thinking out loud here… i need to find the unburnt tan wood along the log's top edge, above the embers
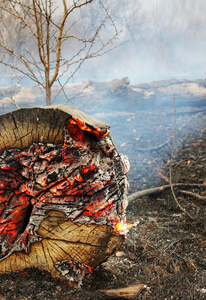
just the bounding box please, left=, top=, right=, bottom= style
left=0, top=105, right=109, bottom=152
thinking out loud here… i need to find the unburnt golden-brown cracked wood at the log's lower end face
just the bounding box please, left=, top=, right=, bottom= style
left=0, top=211, right=123, bottom=278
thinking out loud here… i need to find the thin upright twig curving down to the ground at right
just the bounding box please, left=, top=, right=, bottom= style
left=169, top=95, right=195, bottom=221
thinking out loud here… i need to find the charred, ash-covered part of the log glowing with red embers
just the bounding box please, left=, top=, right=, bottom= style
left=0, top=117, right=130, bottom=273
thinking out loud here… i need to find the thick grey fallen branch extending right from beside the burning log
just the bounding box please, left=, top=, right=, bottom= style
left=127, top=183, right=204, bottom=203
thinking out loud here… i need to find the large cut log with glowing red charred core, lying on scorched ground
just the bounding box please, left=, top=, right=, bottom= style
left=0, top=105, right=128, bottom=281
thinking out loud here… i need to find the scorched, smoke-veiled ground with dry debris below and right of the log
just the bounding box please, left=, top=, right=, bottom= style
left=0, top=90, right=206, bottom=300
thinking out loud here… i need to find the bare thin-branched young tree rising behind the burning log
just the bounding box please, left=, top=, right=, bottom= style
left=0, top=0, right=118, bottom=105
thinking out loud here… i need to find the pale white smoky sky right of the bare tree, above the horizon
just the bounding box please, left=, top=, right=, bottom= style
left=76, top=0, right=206, bottom=84
